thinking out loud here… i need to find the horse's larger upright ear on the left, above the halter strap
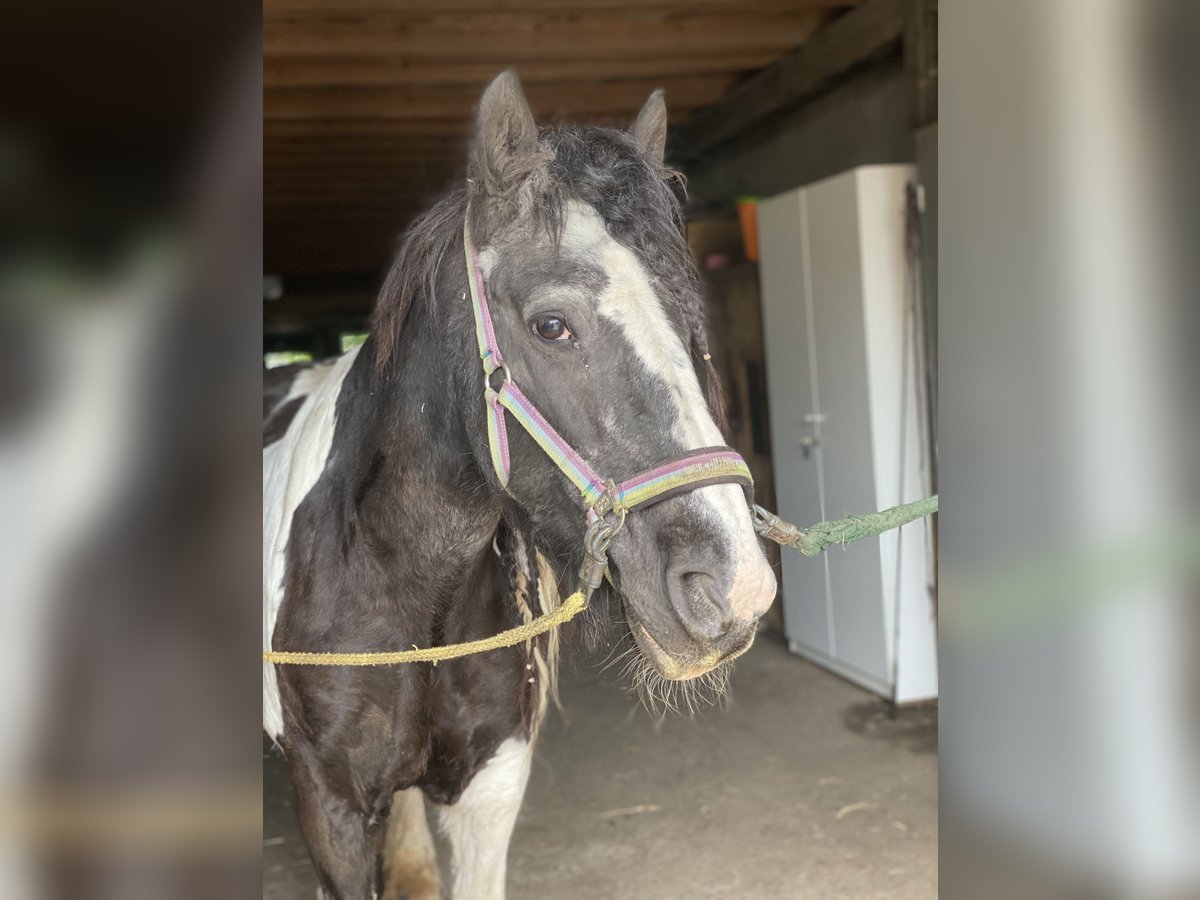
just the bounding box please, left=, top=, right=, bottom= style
left=467, top=68, right=541, bottom=197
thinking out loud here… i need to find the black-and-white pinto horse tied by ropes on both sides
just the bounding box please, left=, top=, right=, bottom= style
left=263, top=72, right=775, bottom=900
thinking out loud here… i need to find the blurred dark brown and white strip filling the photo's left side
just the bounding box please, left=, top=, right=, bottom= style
left=0, top=4, right=262, bottom=898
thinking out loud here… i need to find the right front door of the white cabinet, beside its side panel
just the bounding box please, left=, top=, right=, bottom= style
left=803, top=170, right=899, bottom=692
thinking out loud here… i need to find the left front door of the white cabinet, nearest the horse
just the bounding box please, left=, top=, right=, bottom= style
left=758, top=191, right=832, bottom=656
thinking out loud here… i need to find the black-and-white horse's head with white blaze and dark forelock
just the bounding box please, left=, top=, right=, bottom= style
left=384, top=73, right=775, bottom=696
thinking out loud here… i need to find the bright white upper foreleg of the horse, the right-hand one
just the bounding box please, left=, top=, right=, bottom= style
left=440, top=738, right=533, bottom=900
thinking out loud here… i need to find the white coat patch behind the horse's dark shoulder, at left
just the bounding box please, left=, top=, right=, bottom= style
left=263, top=347, right=359, bottom=740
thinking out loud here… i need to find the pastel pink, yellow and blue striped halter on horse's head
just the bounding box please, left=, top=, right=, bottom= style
left=462, top=216, right=754, bottom=539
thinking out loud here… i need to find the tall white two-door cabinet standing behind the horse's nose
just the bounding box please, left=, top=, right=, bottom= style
left=758, top=166, right=937, bottom=703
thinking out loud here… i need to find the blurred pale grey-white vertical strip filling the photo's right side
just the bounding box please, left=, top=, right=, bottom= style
left=938, top=0, right=1200, bottom=898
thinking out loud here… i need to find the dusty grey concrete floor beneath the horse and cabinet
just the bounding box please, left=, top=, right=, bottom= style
left=263, top=632, right=937, bottom=900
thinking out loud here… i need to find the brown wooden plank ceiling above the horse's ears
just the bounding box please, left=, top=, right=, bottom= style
left=263, top=0, right=856, bottom=275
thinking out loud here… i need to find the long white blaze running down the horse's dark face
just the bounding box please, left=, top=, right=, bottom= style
left=563, top=202, right=775, bottom=619
